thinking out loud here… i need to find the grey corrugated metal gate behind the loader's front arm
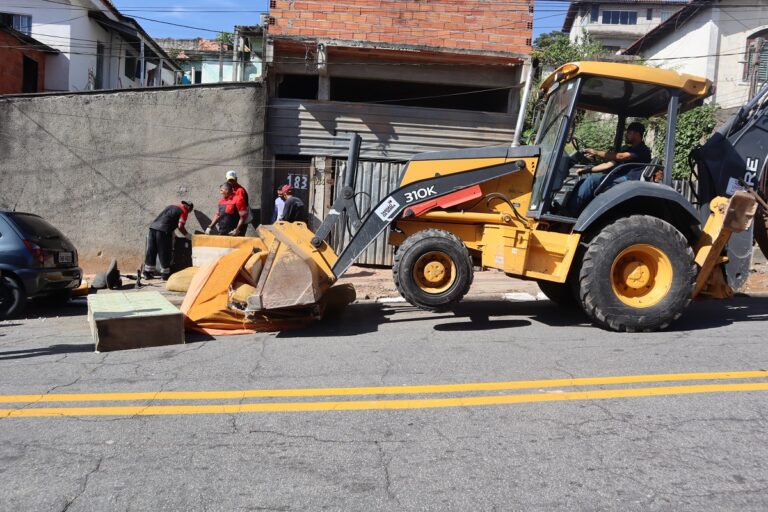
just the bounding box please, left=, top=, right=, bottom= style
left=331, top=160, right=406, bottom=266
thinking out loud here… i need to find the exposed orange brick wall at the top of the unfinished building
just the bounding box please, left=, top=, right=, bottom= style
left=268, top=0, right=533, bottom=54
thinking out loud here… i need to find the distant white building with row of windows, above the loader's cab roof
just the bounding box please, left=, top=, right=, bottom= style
left=563, top=0, right=689, bottom=52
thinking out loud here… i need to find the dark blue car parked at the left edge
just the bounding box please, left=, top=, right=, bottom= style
left=0, top=210, right=83, bottom=317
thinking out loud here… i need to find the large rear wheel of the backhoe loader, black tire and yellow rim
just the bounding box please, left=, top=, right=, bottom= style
left=578, top=215, right=696, bottom=332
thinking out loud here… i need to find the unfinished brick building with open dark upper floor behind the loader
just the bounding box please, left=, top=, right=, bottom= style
left=264, top=0, right=533, bottom=264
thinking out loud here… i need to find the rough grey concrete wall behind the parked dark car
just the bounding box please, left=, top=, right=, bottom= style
left=0, top=82, right=265, bottom=272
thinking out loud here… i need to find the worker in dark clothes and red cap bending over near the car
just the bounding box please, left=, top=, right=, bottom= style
left=143, top=201, right=195, bottom=280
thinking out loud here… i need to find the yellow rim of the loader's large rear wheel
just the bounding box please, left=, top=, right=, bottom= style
left=611, top=244, right=672, bottom=308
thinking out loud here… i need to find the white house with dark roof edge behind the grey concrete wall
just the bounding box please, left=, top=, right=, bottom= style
left=0, top=0, right=180, bottom=91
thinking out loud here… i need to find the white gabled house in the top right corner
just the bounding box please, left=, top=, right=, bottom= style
left=625, top=0, right=768, bottom=109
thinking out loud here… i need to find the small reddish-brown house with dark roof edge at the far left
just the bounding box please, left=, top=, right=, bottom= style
left=0, top=24, right=59, bottom=95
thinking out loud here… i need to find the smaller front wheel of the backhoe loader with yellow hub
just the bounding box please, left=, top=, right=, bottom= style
left=392, top=229, right=473, bottom=311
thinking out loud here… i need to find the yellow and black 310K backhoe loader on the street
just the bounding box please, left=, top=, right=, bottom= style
left=183, top=62, right=768, bottom=331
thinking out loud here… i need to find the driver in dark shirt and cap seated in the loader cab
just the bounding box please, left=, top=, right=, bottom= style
left=568, top=122, right=651, bottom=215
